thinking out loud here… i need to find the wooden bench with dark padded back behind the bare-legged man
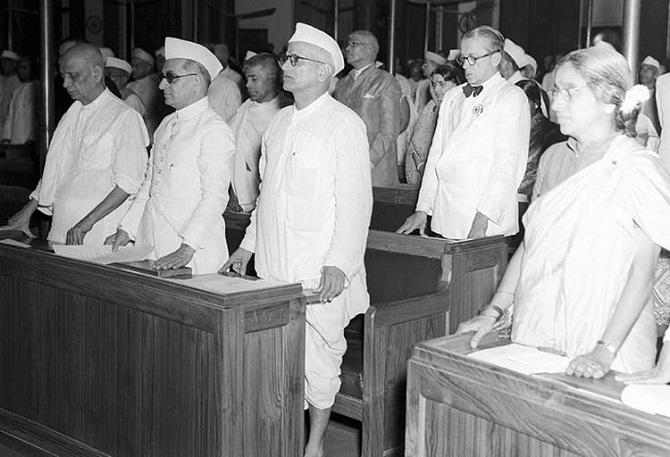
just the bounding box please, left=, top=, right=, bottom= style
left=226, top=217, right=507, bottom=457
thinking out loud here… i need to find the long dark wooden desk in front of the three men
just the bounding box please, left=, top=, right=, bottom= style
left=0, top=240, right=305, bottom=457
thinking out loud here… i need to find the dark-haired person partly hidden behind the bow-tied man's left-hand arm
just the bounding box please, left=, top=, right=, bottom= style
left=405, top=63, right=465, bottom=185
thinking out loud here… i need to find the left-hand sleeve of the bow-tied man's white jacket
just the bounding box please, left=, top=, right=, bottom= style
left=416, top=95, right=452, bottom=215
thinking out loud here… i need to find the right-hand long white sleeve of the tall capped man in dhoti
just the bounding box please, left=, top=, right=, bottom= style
left=324, top=122, right=372, bottom=279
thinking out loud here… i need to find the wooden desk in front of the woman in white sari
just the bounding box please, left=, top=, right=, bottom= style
left=405, top=334, right=670, bottom=457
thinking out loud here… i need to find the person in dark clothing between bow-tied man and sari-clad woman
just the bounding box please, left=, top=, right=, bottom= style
left=516, top=79, right=565, bottom=202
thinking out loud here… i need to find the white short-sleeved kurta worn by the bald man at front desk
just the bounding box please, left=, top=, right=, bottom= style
left=31, top=89, right=149, bottom=244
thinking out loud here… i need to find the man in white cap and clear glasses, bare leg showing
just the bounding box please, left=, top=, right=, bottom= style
left=224, top=23, right=372, bottom=457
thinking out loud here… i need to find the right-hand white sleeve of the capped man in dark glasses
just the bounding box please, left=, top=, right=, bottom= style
left=179, top=124, right=235, bottom=250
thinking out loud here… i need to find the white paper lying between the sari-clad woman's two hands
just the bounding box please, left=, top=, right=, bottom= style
left=469, top=343, right=570, bottom=375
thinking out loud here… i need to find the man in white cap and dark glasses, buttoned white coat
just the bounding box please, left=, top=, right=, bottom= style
left=106, top=37, right=235, bottom=274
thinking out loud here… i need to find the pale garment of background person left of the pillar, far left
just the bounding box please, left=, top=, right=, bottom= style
left=2, top=81, right=39, bottom=144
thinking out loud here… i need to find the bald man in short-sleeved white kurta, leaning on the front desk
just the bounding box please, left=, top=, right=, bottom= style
left=1, top=43, right=149, bottom=244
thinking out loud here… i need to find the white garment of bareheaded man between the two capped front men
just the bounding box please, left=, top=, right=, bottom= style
left=231, top=96, right=280, bottom=211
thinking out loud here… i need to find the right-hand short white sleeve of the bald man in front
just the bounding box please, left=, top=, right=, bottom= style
left=112, top=111, right=149, bottom=195
